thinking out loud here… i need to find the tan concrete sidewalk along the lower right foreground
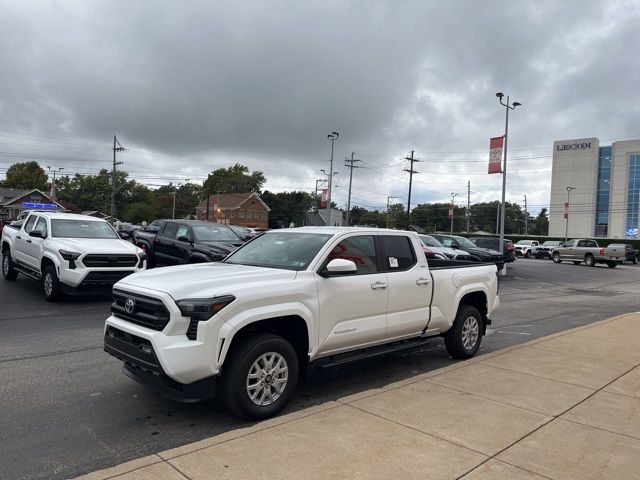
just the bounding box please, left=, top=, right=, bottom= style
left=80, top=313, right=640, bottom=480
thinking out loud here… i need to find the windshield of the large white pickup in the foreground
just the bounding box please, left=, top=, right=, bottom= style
left=224, top=232, right=331, bottom=270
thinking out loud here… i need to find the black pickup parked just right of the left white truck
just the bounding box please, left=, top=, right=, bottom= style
left=134, top=220, right=244, bottom=266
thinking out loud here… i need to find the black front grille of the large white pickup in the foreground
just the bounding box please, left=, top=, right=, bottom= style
left=111, top=289, right=170, bottom=331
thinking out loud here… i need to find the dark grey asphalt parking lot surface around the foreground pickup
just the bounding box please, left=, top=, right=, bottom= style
left=0, top=259, right=640, bottom=479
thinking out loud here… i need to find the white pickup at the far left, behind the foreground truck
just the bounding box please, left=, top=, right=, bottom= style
left=0, top=212, right=146, bottom=301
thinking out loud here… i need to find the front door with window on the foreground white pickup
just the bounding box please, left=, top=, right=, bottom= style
left=315, top=235, right=389, bottom=355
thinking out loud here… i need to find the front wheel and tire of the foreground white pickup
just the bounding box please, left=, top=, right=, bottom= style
left=221, top=333, right=299, bottom=420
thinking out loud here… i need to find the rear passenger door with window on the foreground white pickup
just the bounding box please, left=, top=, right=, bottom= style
left=378, top=235, right=433, bottom=339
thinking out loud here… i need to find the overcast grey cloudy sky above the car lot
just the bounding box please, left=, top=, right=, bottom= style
left=0, top=0, right=640, bottom=211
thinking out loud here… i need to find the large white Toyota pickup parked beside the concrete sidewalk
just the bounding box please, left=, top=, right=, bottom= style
left=104, top=227, right=499, bottom=419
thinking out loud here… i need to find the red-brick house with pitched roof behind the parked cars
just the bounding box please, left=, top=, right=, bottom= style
left=196, top=193, right=271, bottom=230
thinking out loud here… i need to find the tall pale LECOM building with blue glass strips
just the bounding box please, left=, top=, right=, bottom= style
left=549, top=138, right=640, bottom=239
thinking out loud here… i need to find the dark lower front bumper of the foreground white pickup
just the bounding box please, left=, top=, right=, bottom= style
left=104, top=326, right=217, bottom=403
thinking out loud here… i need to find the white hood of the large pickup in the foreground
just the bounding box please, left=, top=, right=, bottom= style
left=114, top=262, right=297, bottom=300
